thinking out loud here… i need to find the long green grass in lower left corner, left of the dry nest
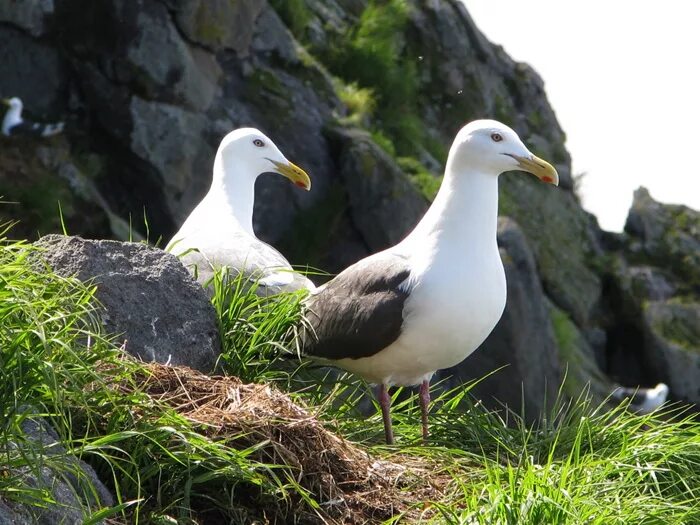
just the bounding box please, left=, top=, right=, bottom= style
left=0, top=236, right=314, bottom=523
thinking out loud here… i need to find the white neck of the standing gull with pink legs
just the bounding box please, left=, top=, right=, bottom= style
left=406, top=159, right=498, bottom=252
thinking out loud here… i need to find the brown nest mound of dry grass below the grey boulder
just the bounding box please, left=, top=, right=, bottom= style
left=117, top=363, right=451, bottom=524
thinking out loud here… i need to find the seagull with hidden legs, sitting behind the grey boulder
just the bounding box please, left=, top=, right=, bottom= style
left=166, top=128, right=315, bottom=295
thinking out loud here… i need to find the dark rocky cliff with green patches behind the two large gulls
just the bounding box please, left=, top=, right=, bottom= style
left=0, top=0, right=700, bottom=416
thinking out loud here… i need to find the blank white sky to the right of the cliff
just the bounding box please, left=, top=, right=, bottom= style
left=463, top=0, right=700, bottom=231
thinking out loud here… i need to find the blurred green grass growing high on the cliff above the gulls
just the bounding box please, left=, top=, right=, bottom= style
left=272, top=0, right=438, bottom=205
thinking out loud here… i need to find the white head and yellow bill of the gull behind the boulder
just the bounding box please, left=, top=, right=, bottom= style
left=214, top=128, right=311, bottom=191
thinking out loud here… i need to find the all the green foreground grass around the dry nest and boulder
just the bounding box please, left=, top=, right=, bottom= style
left=0, top=230, right=700, bottom=524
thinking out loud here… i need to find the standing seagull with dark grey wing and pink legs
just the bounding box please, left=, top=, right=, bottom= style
left=300, top=120, right=559, bottom=444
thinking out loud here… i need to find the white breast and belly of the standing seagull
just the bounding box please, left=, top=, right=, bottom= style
left=338, top=240, right=506, bottom=385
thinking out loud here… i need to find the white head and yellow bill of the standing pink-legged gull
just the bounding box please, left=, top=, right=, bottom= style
left=450, top=120, right=559, bottom=186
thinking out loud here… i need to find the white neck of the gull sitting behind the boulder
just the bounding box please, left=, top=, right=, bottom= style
left=206, top=154, right=257, bottom=235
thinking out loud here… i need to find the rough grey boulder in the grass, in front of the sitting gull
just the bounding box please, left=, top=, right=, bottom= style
left=31, top=235, right=221, bottom=372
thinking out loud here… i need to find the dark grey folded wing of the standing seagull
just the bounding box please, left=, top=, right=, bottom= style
left=301, top=254, right=411, bottom=359
